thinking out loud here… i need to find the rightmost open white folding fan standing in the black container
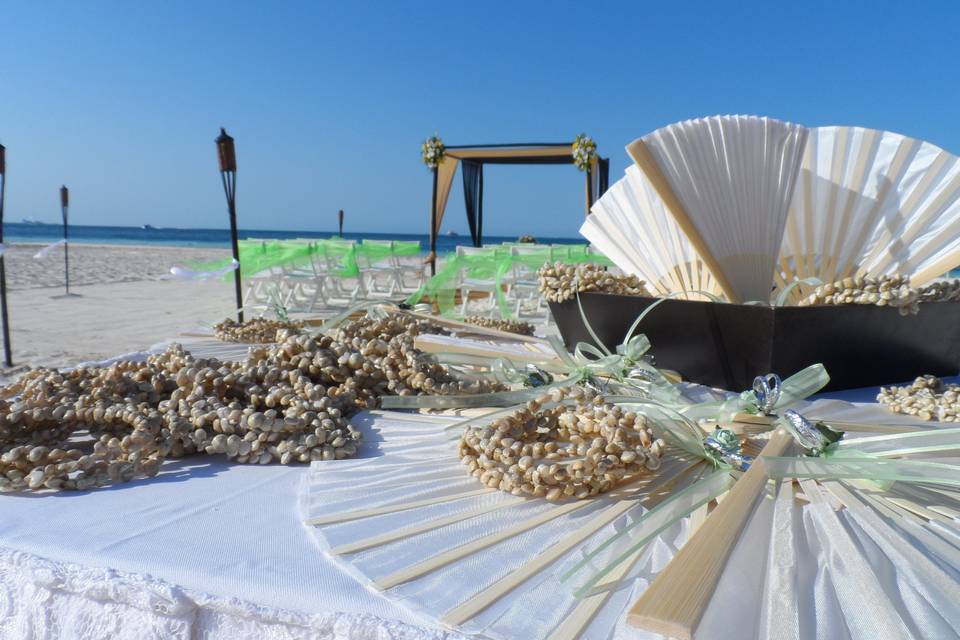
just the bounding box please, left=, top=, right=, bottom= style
left=777, top=127, right=960, bottom=296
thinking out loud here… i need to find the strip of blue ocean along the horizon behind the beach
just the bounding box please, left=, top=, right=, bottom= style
left=3, top=222, right=586, bottom=253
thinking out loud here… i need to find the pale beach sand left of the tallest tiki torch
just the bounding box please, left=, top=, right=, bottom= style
left=5, top=244, right=234, bottom=375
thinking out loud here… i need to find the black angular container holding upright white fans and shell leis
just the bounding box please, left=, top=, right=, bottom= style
left=550, top=293, right=960, bottom=391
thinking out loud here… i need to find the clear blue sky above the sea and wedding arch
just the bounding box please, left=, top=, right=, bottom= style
left=0, top=0, right=960, bottom=236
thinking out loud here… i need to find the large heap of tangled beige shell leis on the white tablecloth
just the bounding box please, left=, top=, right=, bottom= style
left=0, top=316, right=497, bottom=491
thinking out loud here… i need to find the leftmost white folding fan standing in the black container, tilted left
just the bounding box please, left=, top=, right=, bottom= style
left=580, top=166, right=723, bottom=299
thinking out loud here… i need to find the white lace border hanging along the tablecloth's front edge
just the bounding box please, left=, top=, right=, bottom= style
left=0, top=548, right=458, bottom=640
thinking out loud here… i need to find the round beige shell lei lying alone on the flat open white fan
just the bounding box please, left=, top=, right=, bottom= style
left=460, top=386, right=664, bottom=501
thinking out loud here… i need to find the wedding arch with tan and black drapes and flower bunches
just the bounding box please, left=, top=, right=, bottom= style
left=421, top=134, right=610, bottom=270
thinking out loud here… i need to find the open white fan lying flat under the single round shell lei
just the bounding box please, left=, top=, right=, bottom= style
left=301, top=410, right=734, bottom=640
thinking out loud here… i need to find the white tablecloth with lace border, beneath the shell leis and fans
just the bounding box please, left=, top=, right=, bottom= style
left=0, top=358, right=944, bottom=640
